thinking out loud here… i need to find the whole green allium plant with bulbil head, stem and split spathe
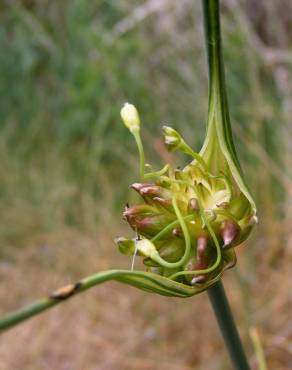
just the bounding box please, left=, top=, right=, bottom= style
left=0, top=0, right=257, bottom=336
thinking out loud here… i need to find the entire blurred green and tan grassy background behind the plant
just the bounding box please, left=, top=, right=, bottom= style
left=0, top=0, right=292, bottom=370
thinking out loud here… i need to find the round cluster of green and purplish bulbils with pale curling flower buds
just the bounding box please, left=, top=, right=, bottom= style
left=116, top=103, right=257, bottom=285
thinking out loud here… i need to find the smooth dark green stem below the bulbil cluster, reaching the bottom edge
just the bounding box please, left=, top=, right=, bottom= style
left=207, top=281, right=250, bottom=370
